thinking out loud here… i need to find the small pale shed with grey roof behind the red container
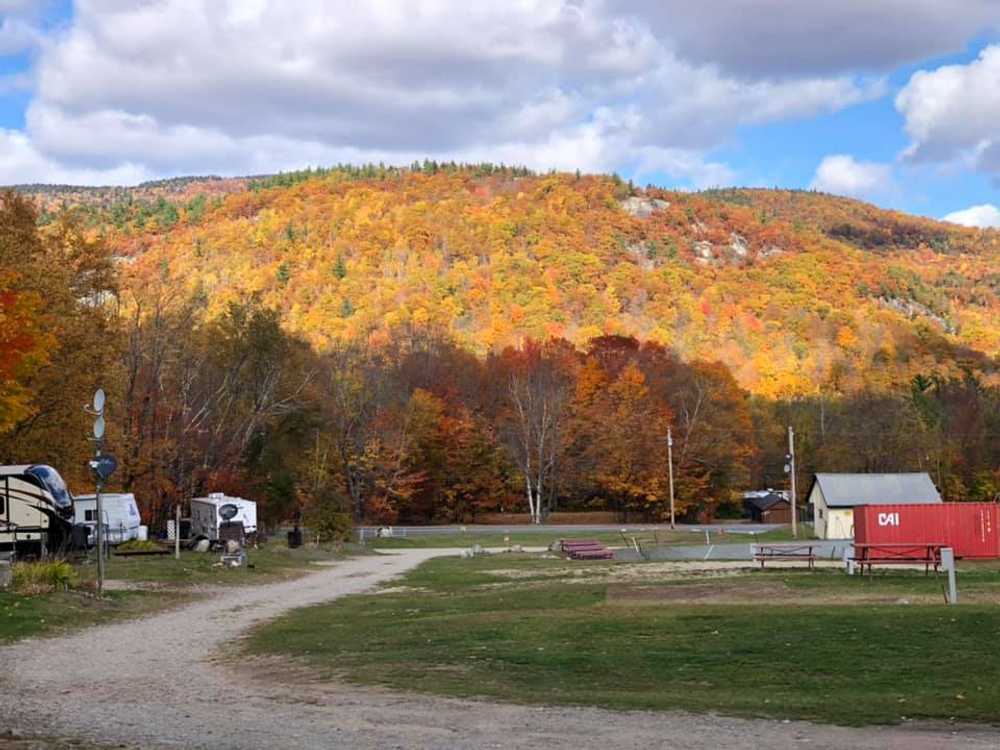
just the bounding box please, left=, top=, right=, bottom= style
left=809, top=472, right=941, bottom=539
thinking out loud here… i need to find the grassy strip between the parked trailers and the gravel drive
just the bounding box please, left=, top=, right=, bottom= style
left=0, top=542, right=354, bottom=644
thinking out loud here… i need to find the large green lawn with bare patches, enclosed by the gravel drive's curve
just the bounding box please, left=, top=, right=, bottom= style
left=248, top=555, right=1000, bottom=725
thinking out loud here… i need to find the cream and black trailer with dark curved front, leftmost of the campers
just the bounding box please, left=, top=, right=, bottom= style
left=0, top=464, right=73, bottom=554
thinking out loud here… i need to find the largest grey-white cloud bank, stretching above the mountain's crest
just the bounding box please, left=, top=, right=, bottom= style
left=0, top=0, right=908, bottom=186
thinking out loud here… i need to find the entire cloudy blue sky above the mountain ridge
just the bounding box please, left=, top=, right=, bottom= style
left=0, top=0, right=1000, bottom=226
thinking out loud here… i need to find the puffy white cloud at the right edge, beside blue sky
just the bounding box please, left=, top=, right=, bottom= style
left=896, top=44, right=1000, bottom=175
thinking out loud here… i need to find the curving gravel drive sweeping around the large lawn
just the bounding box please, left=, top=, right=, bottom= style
left=0, top=549, right=1000, bottom=750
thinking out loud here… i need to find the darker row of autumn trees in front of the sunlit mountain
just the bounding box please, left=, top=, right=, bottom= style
left=0, top=195, right=1000, bottom=531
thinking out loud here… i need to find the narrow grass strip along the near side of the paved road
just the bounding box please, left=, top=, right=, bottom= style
left=365, top=526, right=811, bottom=549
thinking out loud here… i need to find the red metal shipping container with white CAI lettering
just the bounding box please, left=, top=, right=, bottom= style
left=854, top=503, right=1000, bottom=558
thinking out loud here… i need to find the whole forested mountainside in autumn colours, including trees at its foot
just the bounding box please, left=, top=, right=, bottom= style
left=0, top=162, right=1000, bottom=520
